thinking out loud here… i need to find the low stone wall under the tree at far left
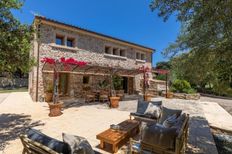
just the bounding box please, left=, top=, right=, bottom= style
left=0, top=77, right=28, bottom=89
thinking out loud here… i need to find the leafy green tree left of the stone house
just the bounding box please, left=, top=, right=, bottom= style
left=0, top=0, right=34, bottom=73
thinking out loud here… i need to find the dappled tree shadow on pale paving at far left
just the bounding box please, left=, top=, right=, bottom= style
left=0, top=114, right=44, bottom=150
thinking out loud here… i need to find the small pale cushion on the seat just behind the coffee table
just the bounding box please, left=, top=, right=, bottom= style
left=144, top=103, right=161, bottom=119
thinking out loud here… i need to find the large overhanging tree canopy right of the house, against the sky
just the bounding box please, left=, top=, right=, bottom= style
left=150, top=0, right=232, bottom=96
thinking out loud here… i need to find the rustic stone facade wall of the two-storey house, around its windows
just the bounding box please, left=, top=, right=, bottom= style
left=29, top=25, right=152, bottom=100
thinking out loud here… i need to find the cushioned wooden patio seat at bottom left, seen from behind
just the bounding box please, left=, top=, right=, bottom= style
left=20, top=129, right=98, bottom=154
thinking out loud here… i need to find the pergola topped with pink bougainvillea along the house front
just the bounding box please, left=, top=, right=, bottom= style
left=41, top=57, right=142, bottom=103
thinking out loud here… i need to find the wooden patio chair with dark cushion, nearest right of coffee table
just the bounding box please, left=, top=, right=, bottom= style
left=130, top=114, right=189, bottom=154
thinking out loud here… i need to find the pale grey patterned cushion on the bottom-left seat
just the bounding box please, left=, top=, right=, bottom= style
left=62, top=133, right=94, bottom=154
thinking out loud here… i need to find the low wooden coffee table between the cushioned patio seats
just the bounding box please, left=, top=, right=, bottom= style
left=97, top=120, right=139, bottom=153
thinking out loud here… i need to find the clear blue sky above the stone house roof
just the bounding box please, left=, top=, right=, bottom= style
left=13, top=0, right=180, bottom=65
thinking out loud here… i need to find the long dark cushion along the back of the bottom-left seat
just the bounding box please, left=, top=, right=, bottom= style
left=26, top=129, right=70, bottom=154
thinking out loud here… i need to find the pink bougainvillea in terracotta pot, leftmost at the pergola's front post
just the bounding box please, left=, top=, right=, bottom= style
left=41, top=57, right=87, bottom=117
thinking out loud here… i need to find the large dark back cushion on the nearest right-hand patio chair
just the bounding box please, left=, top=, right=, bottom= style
left=141, top=124, right=177, bottom=149
